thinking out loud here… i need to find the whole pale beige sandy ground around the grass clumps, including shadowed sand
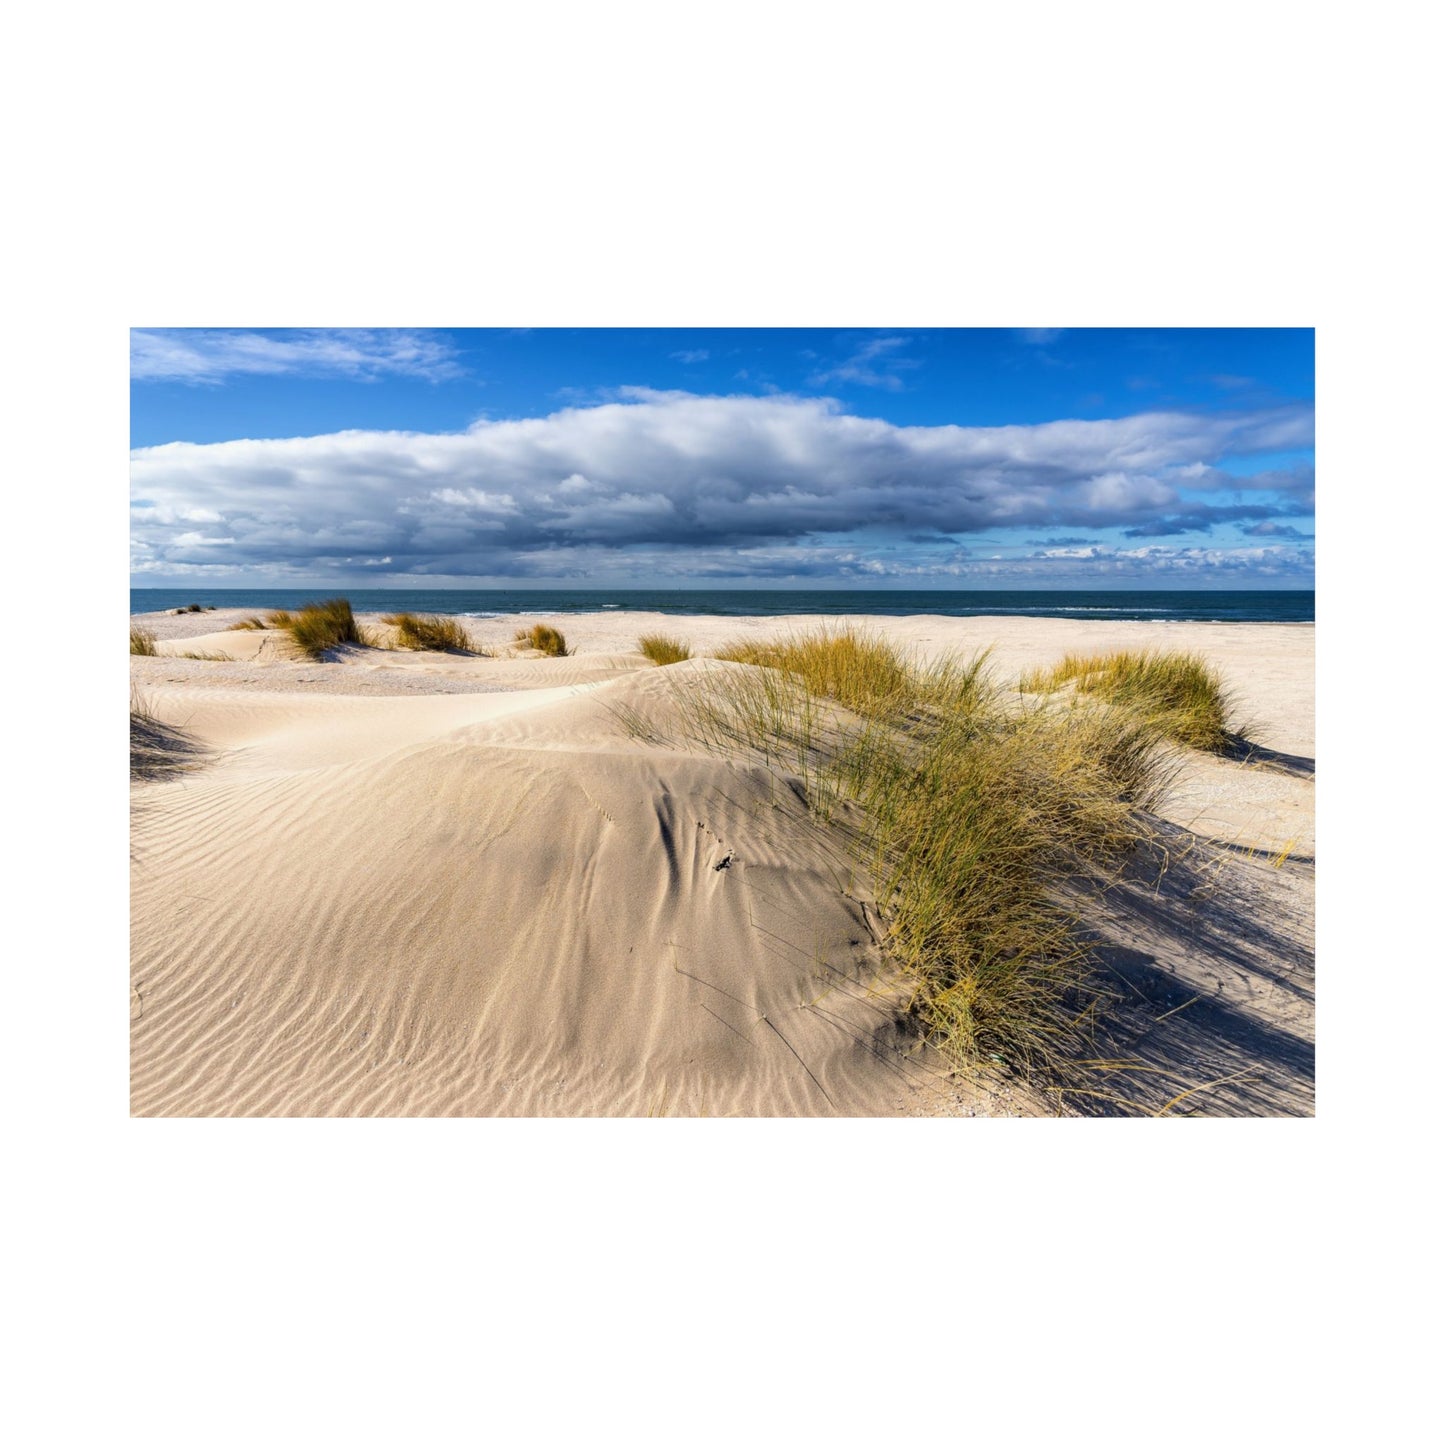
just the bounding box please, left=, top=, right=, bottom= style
left=131, top=611, right=1314, bottom=1116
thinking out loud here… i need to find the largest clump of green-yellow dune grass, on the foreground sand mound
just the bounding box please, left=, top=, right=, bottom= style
left=644, top=629, right=1170, bottom=1068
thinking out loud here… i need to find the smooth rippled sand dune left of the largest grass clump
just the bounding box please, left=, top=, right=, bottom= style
left=133, top=664, right=947, bottom=1116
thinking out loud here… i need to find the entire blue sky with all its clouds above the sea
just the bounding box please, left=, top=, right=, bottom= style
left=131, top=328, right=1314, bottom=588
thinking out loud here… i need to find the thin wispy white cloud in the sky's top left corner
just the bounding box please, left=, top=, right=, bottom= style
left=130, top=329, right=461, bottom=384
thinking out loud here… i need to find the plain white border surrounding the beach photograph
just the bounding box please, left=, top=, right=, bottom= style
left=0, top=0, right=1441, bottom=1442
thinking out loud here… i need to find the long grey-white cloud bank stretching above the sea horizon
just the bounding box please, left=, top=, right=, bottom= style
left=131, top=390, right=1314, bottom=584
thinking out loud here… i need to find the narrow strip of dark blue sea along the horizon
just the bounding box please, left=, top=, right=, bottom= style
left=130, top=587, right=1315, bottom=623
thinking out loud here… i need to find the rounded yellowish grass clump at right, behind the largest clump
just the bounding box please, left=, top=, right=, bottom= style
left=1019, top=650, right=1240, bottom=753
